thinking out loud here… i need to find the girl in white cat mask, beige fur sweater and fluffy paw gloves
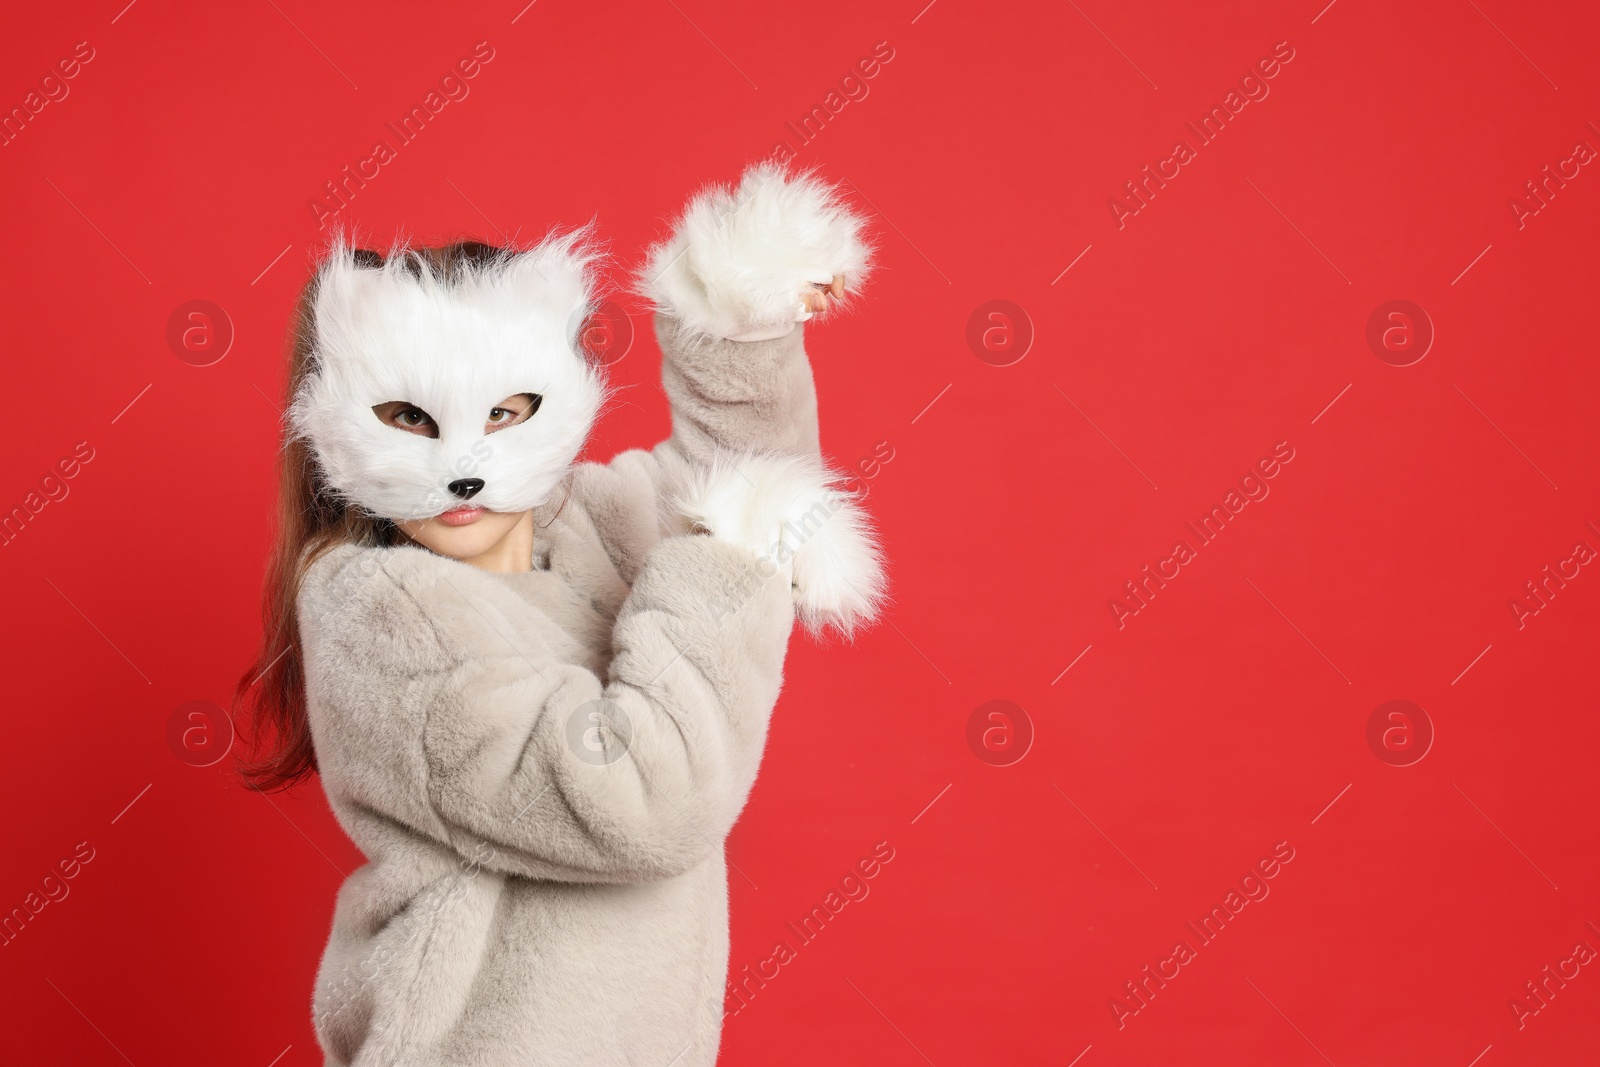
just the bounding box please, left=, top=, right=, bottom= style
left=240, top=166, right=883, bottom=1067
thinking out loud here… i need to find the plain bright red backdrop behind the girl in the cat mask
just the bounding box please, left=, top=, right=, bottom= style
left=0, top=0, right=1600, bottom=1067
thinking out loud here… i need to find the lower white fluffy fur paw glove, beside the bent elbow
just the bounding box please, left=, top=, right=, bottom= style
left=667, top=453, right=886, bottom=637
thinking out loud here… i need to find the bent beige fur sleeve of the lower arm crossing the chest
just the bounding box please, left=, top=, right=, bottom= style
left=299, top=537, right=794, bottom=883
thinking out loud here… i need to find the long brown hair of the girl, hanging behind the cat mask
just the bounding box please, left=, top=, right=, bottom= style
left=234, top=242, right=509, bottom=792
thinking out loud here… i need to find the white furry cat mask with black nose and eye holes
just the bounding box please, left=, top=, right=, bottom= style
left=290, top=230, right=605, bottom=520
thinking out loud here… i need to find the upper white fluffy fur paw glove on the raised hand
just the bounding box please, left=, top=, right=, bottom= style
left=640, top=163, right=872, bottom=341
